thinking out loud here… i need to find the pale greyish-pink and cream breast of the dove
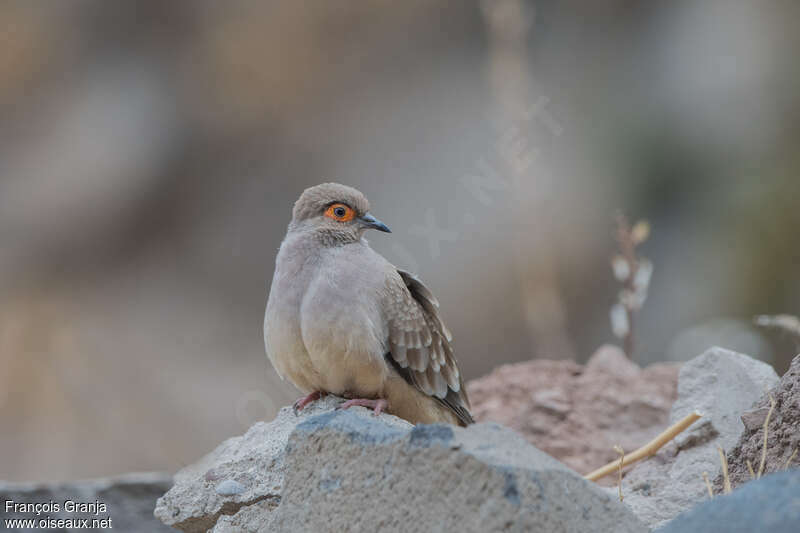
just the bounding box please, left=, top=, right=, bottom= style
left=264, top=236, right=391, bottom=397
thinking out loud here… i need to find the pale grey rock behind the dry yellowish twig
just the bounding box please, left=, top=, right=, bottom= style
left=623, top=348, right=778, bottom=527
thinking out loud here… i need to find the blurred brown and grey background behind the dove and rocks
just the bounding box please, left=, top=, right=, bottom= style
left=0, top=0, right=800, bottom=481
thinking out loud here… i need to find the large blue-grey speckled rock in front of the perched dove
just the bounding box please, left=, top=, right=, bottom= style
left=247, top=411, right=647, bottom=533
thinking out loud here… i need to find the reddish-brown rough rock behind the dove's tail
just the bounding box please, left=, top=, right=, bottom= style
left=467, top=345, right=678, bottom=484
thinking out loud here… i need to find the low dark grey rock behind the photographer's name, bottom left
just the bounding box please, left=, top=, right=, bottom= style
left=0, top=473, right=172, bottom=533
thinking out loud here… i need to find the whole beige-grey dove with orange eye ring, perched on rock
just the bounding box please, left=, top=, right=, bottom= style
left=264, top=183, right=473, bottom=425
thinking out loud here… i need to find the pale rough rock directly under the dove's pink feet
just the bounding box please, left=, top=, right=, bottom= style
left=155, top=395, right=411, bottom=532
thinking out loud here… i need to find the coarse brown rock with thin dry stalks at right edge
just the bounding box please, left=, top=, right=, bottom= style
left=714, top=355, right=800, bottom=491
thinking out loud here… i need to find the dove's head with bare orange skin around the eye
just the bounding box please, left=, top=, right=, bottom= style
left=289, top=183, right=391, bottom=246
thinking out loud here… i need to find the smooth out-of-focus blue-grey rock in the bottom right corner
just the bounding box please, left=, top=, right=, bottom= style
left=657, top=470, right=800, bottom=533
